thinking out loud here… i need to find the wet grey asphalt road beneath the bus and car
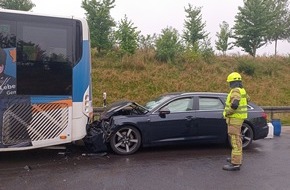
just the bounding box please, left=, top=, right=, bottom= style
left=0, top=127, right=290, bottom=190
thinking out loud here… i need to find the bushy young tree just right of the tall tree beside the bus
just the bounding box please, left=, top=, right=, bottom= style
left=116, top=15, right=140, bottom=54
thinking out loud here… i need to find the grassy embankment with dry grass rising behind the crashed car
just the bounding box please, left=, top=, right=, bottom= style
left=92, top=50, right=290, bottom=123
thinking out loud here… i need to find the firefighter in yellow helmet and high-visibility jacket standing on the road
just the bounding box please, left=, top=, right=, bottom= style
left=223, top=72, right=249, bottom=171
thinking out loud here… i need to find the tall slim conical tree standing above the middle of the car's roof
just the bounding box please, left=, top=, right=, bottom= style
left=183, top=4, right=208, bottom=50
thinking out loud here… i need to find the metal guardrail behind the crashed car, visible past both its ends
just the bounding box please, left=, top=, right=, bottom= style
left=94, top=106, right=290, bottom=120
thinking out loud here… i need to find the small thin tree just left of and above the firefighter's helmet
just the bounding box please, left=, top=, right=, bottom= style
left=215, top=21, right=233, bottom=55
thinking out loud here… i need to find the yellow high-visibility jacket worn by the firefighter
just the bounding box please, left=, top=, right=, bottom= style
left=223, top=88, right=248, bottom=119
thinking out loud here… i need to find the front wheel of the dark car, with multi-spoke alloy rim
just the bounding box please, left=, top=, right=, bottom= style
left=110, top=126, right=141, bottom=155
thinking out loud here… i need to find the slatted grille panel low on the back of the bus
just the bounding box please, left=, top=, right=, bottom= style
left=2, top=103, right=69, bottom=145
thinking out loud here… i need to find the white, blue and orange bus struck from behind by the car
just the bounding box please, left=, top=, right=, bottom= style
left=0, top=9, right=93, bottom=151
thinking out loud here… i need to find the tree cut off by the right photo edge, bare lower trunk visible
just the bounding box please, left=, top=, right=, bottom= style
left=269, top=0, right=290, bottom=56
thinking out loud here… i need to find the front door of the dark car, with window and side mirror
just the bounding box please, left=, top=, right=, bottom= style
left=149, top=97, right=195, bottom=144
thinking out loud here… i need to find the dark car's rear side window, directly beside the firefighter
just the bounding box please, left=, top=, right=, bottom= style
left=199, top=97, right=224, bottom=110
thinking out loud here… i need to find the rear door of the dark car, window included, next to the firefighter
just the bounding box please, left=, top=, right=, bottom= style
left=194, top=96, right=227, bottom=141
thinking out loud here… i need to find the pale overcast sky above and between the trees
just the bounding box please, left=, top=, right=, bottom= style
left=32, top=0, right=290, bottom=56
